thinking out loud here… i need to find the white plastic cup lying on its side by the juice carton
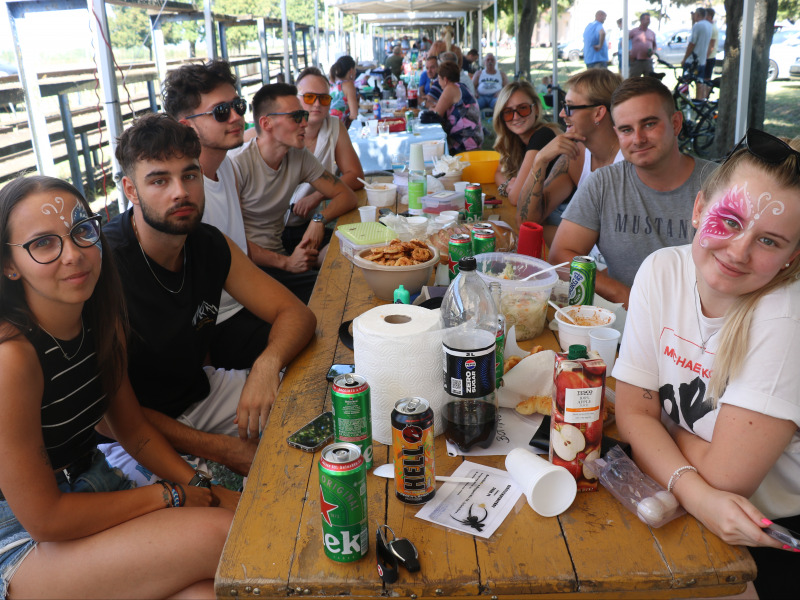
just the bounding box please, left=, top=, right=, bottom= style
left=506, top=448, right=578, bottom=517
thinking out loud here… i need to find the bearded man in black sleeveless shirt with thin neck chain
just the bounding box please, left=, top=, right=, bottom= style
left=101, top=114, right=316, bottom=484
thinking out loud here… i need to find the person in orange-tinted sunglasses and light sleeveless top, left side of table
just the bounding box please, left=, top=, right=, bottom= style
left=282, top=67, right=364, bottom=255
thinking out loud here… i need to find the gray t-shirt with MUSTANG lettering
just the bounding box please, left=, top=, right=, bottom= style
left=563, top=158, right=717, bottom=287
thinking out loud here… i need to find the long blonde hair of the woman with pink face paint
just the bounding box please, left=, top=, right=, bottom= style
left=702, top=136, right=800, bottom=407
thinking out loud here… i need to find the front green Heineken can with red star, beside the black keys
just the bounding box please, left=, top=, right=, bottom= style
left=319, top=442, right=369, bottom=563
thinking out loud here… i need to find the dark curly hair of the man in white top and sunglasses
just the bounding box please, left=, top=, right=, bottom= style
left=161, top=60, right=236, bottom=119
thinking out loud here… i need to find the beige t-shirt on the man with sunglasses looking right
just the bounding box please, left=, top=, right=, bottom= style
left=228, top=138, right=325, bottom=254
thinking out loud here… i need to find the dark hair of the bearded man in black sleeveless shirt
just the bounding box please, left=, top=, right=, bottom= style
left=115, top=113, right=201, bottom=177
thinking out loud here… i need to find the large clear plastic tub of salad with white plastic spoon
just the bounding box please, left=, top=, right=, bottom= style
left=475, top=252, right=556, bottom=341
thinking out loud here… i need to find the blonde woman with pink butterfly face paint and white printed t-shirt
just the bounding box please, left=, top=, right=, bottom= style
left=613, top=129, right=800, bottom=598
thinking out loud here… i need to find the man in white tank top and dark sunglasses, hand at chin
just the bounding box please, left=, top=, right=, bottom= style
left=517, top=69, right=623, bottom=239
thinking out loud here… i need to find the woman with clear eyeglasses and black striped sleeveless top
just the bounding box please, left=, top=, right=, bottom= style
left=0, top=177, right=233, bottom=598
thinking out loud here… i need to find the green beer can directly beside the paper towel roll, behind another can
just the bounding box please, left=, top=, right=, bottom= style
left=331, top=373, right=372, bottom=471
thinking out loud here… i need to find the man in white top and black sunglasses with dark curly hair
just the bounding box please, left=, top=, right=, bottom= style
left=163, top=60, right=269, bottom=369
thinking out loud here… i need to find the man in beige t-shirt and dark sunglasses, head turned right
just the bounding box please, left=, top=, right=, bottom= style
left=232, top=83, right=358, bottom=303
